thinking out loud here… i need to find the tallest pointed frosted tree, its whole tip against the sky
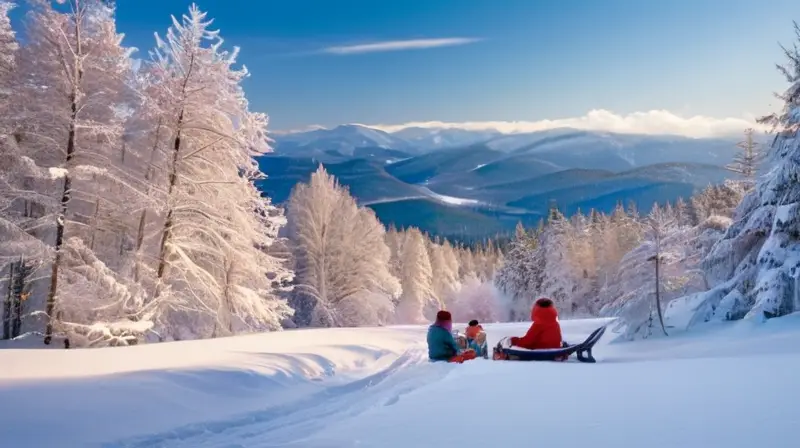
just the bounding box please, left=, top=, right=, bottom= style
left=137, top=5, right=291, bottom=339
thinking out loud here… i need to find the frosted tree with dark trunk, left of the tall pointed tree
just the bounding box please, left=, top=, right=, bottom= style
left=9, top=0, right=154, bottom=343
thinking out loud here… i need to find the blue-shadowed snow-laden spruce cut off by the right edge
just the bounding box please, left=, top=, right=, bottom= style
left=676, top=23, right=800, bottom=326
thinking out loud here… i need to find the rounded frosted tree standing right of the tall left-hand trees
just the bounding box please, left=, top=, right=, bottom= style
left=288, top=166, right=400, bottom=326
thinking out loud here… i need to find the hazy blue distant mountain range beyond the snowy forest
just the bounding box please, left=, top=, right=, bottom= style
left=259, top=125, right=752, bottom=239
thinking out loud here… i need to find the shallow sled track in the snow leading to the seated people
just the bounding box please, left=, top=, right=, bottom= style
left=102, top=350, right=441, bottom=448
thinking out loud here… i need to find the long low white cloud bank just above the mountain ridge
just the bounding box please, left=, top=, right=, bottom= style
left=358, top=109, right=767, bottom=138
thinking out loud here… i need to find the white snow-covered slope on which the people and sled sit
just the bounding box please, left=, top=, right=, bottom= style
left=0, top=314, right=800, bottom=448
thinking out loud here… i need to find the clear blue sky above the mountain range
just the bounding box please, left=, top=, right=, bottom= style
left=9, top=0, right=800, bottom=133
